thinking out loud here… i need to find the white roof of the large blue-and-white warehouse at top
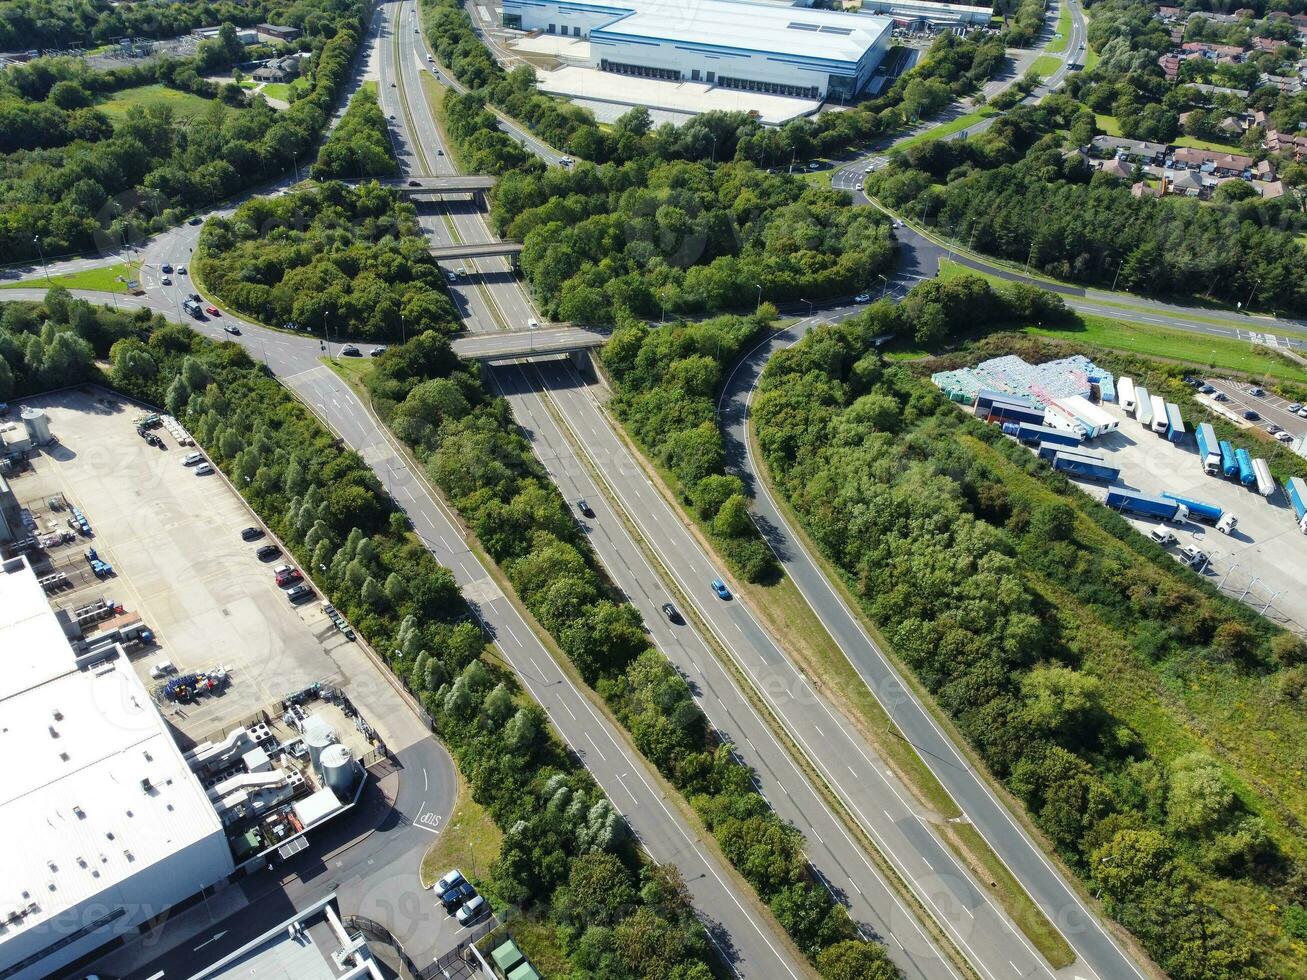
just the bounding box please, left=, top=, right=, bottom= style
left=588, top=0, right=893, bottom=63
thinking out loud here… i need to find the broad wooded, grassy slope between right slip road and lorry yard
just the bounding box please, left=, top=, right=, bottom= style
left=753, top=280, right=1307, bottom=980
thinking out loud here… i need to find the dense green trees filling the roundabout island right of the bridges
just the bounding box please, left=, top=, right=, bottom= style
left=491, top=158, right=893, bottom=324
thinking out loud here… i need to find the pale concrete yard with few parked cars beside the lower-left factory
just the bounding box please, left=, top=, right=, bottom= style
left=12, top=389, right=421, bottom=747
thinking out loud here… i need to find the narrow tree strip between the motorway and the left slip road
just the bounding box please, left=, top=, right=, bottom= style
left=366, top=327, right=898, bottom=980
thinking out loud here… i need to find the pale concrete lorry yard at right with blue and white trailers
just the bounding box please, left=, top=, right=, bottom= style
left=1061, top=402, right=1307, bottom=631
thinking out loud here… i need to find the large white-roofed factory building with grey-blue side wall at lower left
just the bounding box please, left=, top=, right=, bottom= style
left=0, top=558, right=233, bottom=980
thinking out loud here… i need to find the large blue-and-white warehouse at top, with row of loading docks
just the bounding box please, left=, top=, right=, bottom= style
left=503, top=0, right=894, bottom=101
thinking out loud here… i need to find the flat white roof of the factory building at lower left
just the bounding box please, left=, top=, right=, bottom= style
left=0, top=559, right=221, bottom=934
